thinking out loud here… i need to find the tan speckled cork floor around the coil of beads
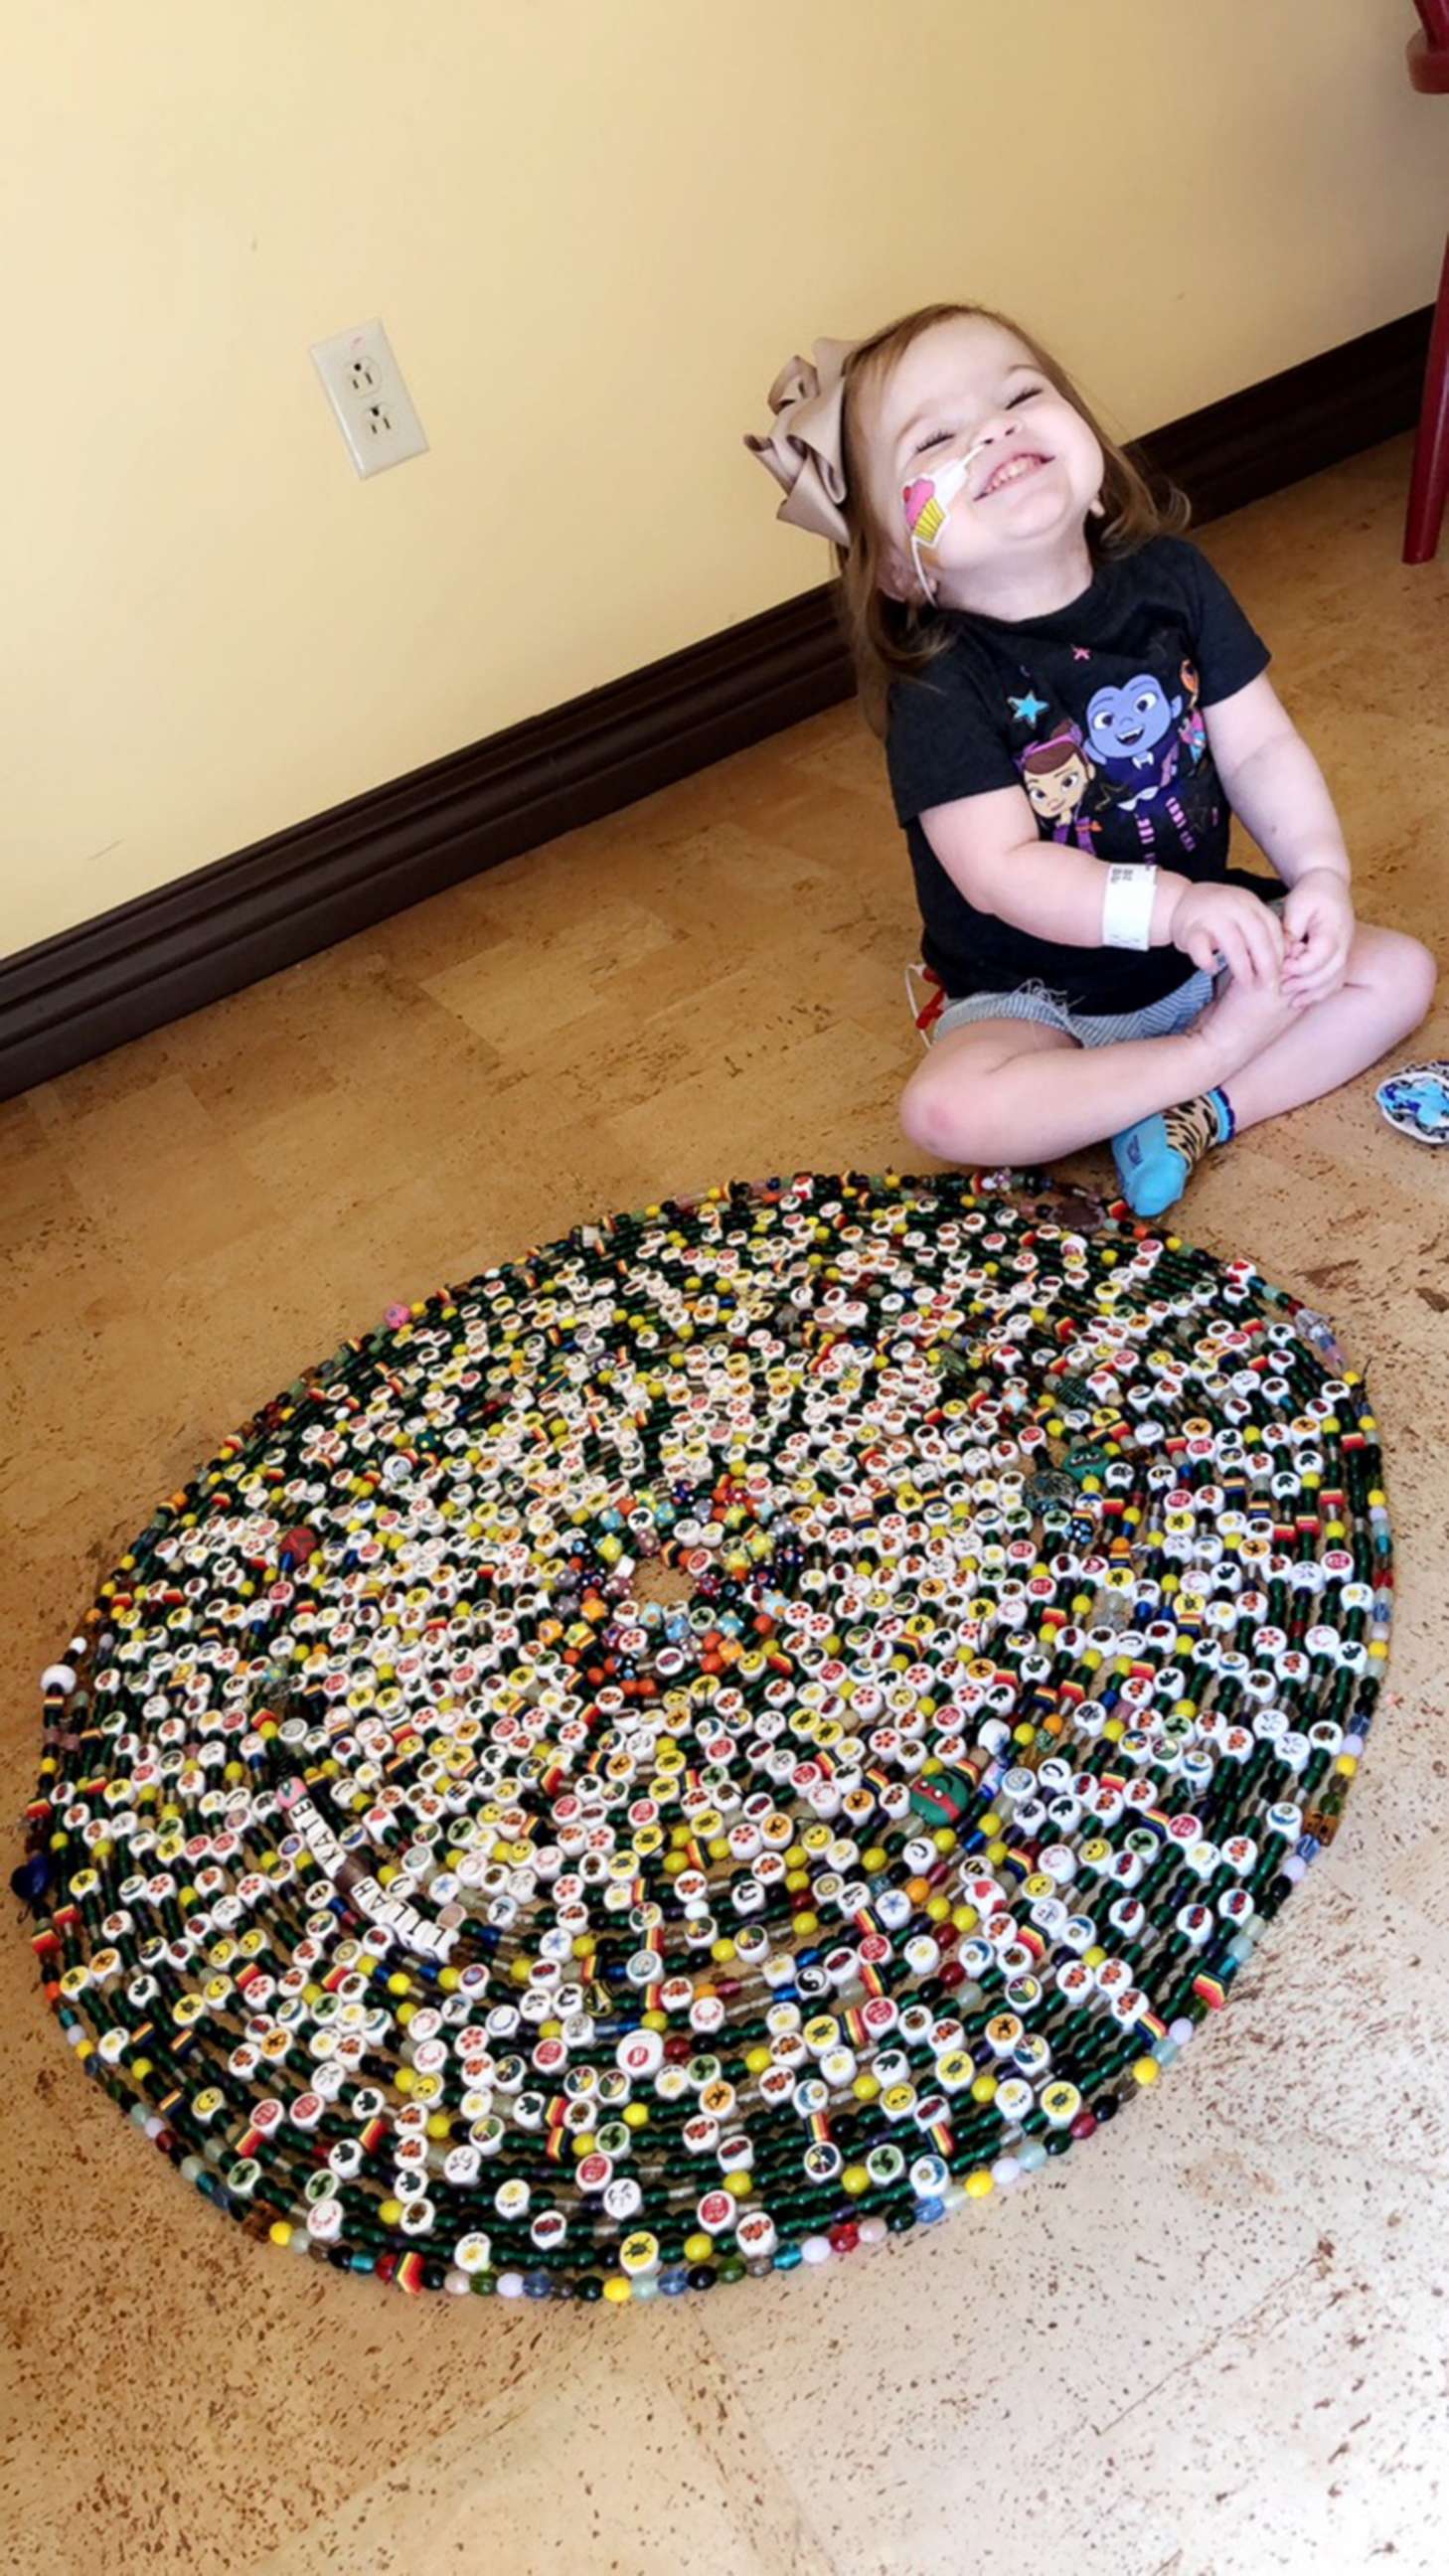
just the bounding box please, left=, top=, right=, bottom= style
left=0, top=440, right=1449, bottom=2576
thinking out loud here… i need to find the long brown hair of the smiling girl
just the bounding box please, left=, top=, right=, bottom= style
left=836, top=304, right=1189, bottom=734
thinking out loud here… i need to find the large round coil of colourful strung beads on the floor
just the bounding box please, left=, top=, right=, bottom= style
left=16, top=1172, right=1392, bottom=2306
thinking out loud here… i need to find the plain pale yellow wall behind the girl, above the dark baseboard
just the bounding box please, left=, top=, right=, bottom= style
left=0, top=0, right=1449, bottom=948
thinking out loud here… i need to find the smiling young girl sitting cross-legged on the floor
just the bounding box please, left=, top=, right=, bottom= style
left=747, top=304, right=1436, bottom=1215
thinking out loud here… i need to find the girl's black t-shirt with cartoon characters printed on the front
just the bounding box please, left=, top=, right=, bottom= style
left=886, top=536, right=1276, bottom=1013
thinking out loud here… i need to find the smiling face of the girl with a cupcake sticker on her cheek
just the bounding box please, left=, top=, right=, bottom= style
left=864, top=314, right=1103, bottom=615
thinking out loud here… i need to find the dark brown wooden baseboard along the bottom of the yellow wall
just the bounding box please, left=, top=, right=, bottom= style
left=0, top=306, right=1431, bottom=1100
